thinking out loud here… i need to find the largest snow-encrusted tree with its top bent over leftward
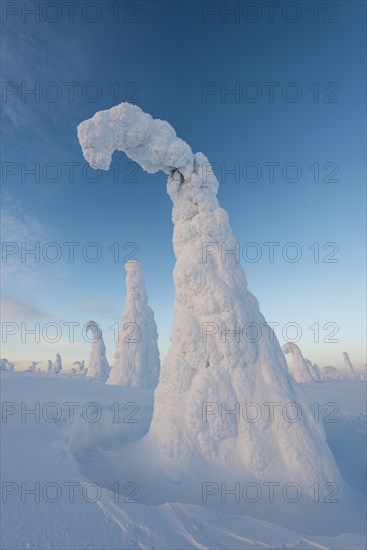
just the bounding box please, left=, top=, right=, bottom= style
left=78, top=103, right=341, bottom=492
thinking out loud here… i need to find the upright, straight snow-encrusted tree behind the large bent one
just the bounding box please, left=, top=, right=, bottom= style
left=107, top=260, right=160, bottom=388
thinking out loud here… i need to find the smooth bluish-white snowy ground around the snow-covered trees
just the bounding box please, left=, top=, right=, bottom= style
left=1, top=372, right=366, bottom=550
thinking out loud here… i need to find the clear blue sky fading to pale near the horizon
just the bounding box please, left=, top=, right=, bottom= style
left=2, top=0, right=366, bottom=374
